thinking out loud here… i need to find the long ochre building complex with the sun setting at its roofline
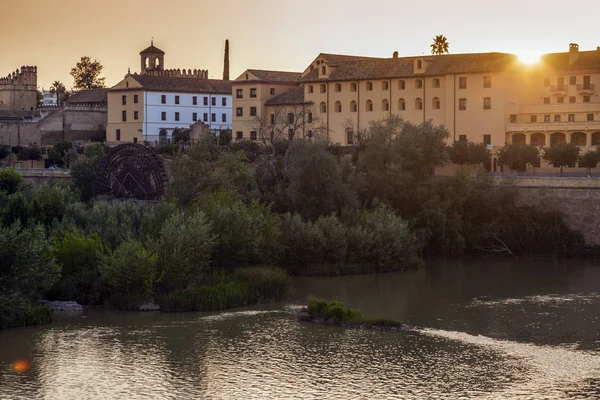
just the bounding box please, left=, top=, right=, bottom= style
left=233, top=44, right=600, bottom=155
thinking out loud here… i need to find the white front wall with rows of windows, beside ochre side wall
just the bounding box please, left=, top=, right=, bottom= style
left=143, top=92, right=232, bottom=142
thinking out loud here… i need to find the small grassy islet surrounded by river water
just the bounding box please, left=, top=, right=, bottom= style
left=308, top=296, right=402, bottom=327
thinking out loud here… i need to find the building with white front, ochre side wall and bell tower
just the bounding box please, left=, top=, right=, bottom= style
left=106, top=43, right=232, bottom=145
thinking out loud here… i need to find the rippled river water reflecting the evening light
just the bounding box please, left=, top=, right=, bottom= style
left=0, top=260, right=600, bottom=400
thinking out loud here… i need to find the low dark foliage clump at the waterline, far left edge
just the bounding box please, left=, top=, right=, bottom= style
left=0, top=296, right=52, bottom=329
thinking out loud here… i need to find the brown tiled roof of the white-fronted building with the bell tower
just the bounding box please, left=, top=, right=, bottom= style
left=127, top=75, right=233, bottom=95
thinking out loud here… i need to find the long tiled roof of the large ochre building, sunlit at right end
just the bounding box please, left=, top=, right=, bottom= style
left=302, top=53, right=517, bottom=82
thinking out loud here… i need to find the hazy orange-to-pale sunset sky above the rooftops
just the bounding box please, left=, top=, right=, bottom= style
left=0, top=0, right=600, bottom=89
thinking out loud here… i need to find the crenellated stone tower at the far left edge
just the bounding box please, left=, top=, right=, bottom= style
left=0, top=66, right=37, bottom=111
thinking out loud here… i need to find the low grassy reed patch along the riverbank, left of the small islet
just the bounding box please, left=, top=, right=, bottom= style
left=157, top=267, right=290, bottom=312
